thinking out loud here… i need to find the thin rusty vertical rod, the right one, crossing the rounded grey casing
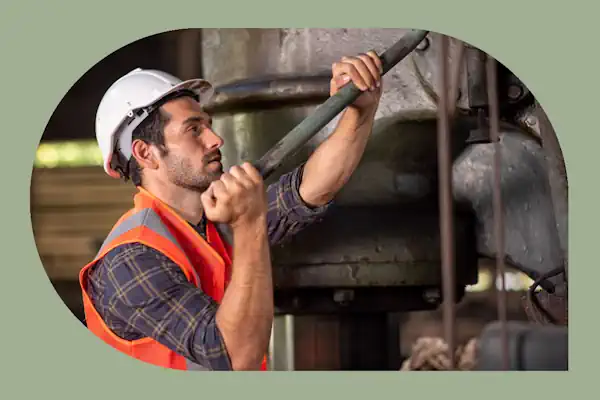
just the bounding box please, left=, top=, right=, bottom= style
left=486, top=55, right=509, bottom=370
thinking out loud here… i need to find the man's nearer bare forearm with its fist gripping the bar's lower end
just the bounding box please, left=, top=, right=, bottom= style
left=202, top=163, right=274, bottom=370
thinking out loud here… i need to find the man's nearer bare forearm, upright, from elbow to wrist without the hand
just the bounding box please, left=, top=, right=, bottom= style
left=216, top=217, right=273, bottom=370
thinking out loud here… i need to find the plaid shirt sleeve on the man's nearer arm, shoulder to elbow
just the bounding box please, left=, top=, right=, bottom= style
left=90, top=244, right=232, bottom=370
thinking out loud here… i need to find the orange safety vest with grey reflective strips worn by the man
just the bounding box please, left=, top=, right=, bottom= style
left=79, top=188, right=267, bottom=371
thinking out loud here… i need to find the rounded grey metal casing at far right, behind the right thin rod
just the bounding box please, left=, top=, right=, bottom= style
left=453, top=128, right=563, bottom=291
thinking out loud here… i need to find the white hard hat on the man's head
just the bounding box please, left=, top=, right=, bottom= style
left=96, top=68, right=214, bottom=178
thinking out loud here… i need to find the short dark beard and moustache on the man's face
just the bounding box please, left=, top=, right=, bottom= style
left=164, top=151, right=223, bottom=193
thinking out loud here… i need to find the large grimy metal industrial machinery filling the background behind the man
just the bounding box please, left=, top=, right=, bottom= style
left=202, top=29, right=567, bottom=369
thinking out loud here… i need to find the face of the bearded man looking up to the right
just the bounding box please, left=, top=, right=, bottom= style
left=160, top=97, right=223, bottom=192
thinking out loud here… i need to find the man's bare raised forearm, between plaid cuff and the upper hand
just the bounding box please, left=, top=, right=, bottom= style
left=300, top=107, right=377, bottom=206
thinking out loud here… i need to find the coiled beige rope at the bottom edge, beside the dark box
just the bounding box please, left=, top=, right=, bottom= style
left=400, top=337, right=477, bottom=371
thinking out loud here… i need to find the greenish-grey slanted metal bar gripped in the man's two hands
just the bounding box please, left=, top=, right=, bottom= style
left=254, top=29, right=429, bottom=179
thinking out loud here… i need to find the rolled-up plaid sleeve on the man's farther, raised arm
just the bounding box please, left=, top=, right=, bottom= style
left=267, top=164, right=333, bottom=245
